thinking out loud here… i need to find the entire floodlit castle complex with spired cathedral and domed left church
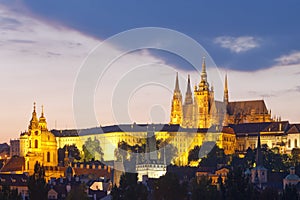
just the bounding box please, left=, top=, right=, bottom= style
left=1, top=60, right=300, bottom=177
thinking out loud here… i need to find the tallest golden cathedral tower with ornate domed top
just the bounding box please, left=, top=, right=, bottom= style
left=194, top=58, right=211, bottom=128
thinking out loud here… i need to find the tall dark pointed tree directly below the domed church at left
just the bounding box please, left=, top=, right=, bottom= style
left=28, top=162, right=47, bottom=200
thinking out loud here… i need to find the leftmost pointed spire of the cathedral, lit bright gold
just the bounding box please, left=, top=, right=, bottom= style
left=170, top=73, right=183, bottom=125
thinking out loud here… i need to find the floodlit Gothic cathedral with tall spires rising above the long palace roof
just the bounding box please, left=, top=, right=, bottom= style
left=170, top=58, right=273, bottom=128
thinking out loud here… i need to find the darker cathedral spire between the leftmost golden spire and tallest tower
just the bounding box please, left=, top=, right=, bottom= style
left=182, top=75, right=194, bottom=127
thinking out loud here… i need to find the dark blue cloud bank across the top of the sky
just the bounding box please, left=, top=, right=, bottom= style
left=12, top=0, right=300, bottom=71
